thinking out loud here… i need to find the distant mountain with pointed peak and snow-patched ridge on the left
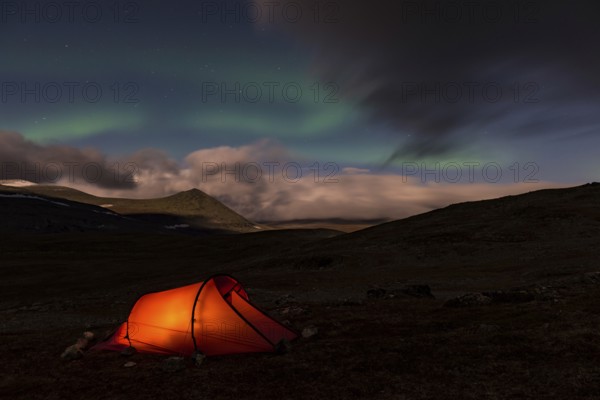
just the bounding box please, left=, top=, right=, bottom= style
left=0, top=185, right=259, bottom=232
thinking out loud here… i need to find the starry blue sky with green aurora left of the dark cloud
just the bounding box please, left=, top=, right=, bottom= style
left=1, top=2, right=364, bottom=156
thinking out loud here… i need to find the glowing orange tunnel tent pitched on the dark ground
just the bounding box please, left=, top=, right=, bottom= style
left=95, top=275, right=298, bottom=356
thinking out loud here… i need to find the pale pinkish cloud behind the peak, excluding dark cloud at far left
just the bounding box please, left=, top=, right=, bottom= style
left=63, top=141, right=556, bottom=221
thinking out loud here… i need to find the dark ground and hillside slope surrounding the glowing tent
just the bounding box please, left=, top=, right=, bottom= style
left=0, top=184, right=600, bottom=400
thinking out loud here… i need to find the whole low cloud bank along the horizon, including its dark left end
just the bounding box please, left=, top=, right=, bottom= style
left=0, top=132, right=560, bottom=221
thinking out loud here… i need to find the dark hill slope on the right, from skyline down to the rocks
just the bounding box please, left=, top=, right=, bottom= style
left=262, top=183, right=600, bottom=291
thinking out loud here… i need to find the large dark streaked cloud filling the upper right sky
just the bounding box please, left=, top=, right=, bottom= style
left=258, top=0, right=600, bottom=158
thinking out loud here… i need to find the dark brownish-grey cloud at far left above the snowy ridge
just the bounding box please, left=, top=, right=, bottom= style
left=0, top=132, right=137, bottom=189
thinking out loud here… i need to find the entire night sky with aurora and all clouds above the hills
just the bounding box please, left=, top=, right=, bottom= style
left=0, top=0, right=600, bottom=220
